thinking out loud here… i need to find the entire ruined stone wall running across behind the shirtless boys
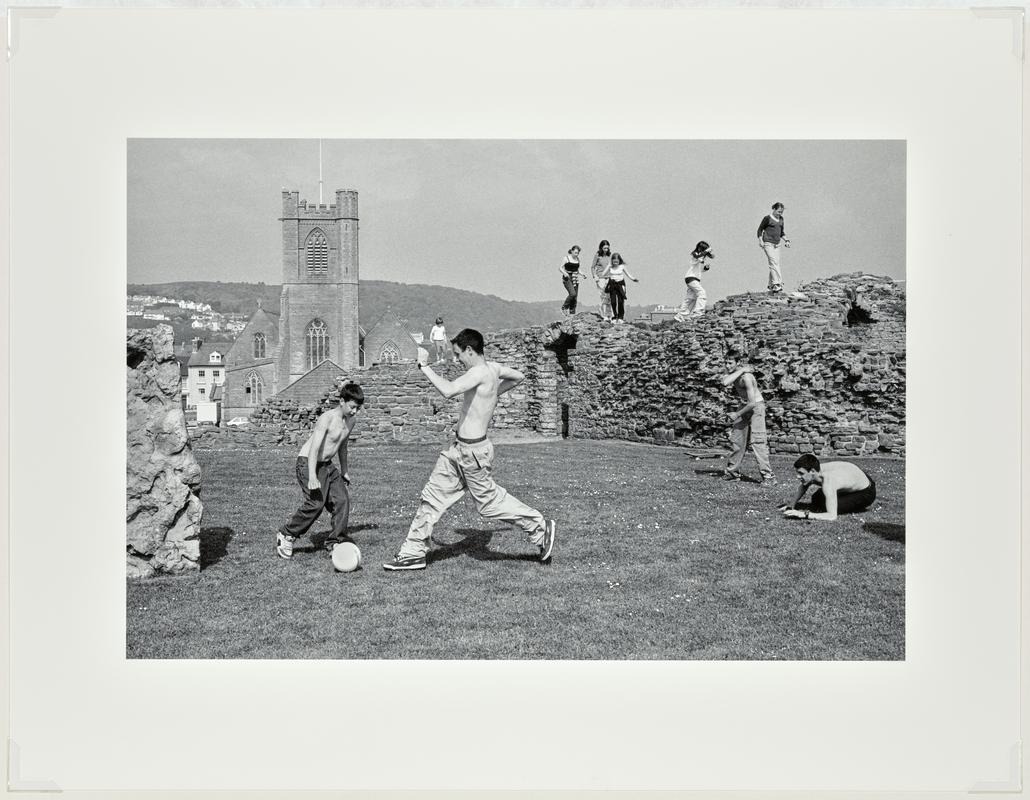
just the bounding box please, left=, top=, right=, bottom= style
left=202, top=274, right=905, bottom=455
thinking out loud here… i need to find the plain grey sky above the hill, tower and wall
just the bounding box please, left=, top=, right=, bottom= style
left=128, top=139, right=905, bottom=305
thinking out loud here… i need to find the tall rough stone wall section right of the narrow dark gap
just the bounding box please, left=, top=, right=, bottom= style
left=553, top=274, right=905, bottom=455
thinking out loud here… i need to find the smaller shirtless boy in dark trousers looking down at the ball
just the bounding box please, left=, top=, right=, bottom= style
left=275, top=383, right=365, bottom=559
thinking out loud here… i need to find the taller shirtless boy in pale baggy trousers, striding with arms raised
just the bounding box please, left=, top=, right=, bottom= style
left=383, top=327, right=555, bottom=571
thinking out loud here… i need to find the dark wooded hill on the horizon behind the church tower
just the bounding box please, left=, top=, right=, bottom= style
left=128, top=280, right=646, bottom=338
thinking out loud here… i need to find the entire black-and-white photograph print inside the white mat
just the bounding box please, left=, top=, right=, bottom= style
left=126, top=139, right=905, bottom=660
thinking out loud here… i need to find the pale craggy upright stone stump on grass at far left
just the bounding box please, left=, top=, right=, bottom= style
left=126, top=325, right=203, bottom=578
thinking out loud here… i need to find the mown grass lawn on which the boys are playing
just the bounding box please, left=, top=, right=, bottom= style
left=127, top=441, right=904, bottom=660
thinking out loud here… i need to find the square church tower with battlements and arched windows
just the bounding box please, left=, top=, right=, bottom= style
left=278, top=189, right=358, bottom=383
